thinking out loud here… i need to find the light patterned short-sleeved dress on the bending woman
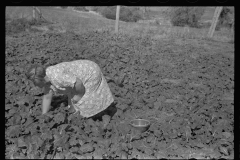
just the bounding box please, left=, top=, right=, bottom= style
left=46, top=60, right=114, bottom=117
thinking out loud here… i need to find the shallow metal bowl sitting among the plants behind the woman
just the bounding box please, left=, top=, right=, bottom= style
left=130, top=119, right=150, bottom=133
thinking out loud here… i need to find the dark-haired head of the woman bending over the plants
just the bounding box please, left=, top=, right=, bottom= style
left=26, top=65, right=46, bottom=84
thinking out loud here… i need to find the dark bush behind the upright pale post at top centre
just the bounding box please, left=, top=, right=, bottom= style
left=101, top=6, right=142, bottom=22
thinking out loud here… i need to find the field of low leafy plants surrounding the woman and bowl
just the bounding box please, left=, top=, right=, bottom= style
left=5, top=31, right=234, bottom=159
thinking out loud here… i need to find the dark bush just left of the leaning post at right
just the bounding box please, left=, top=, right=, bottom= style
left=170, top=7, right=204, bottom=27
